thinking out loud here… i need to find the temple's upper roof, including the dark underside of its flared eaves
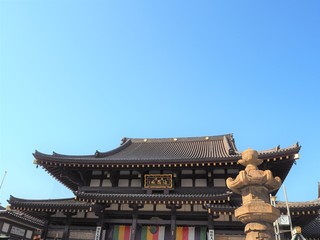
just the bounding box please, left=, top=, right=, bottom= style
left=34, top=134, right=300, bottom=191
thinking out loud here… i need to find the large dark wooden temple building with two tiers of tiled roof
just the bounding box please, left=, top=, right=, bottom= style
left=4, top=134, right=320, bottom=240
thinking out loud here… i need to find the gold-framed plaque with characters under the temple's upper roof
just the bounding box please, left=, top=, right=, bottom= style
left=144, top=174, right=172, bottom=189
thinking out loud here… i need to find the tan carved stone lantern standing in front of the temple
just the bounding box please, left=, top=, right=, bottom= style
left=226, top=148, right=282, bottom=240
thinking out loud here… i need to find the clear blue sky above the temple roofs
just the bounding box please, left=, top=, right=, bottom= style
left=0, top=0, right=320, bottom=206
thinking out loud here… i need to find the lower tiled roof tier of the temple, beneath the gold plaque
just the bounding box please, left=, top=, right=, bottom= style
left=9, top=192, right=234, bottom=214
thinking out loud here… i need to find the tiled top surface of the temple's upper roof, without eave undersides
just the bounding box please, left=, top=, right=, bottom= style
left=34, top=134, right=300, bottom=164
